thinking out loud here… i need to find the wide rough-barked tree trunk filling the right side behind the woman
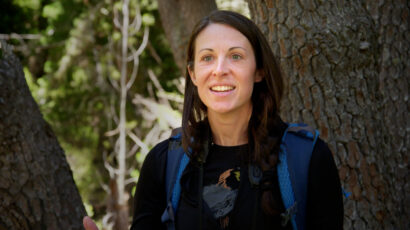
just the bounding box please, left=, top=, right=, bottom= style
left=248, top=0, right=410, bottom=229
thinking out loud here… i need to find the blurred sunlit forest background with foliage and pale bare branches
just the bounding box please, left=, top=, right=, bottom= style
left=0, top=0, right=249, bottom=229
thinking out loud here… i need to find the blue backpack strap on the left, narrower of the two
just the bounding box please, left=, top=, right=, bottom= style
left=161, top=129, right=189, bottom=230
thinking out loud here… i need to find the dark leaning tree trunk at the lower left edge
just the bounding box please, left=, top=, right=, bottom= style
left=0, top=43, right=86, bottom=229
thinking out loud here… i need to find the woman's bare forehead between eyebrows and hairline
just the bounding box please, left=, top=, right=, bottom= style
left=195, top=23, right=252, bottom=51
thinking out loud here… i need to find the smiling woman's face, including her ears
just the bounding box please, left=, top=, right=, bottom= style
left=188, top=23, right=262, bottom=115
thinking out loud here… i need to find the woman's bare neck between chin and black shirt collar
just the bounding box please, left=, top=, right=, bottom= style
left=208, top=107, right=252, bottom=146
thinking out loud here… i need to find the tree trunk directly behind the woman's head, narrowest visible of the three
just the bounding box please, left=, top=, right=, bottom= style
left=158, top=0, right=217, bottom=75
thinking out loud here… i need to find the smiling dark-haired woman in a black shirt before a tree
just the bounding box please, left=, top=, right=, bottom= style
left=83, top=11, right=343, bottom=229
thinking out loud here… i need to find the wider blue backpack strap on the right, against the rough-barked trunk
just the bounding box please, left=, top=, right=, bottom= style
left=277, top=124, right=319, bottom=230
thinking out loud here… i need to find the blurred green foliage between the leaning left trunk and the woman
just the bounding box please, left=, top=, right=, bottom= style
left=0, top=0, right=181, bottom=224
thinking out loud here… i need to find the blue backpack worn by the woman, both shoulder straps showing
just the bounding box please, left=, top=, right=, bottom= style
left=161, top=124, right=319, bottom=230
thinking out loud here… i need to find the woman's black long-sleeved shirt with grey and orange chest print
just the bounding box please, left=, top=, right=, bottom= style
left=131, top=139, right=343, bottom=230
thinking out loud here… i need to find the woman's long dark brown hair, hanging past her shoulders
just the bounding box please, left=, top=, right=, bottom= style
left=182, top=10, right=284, bottom=215
